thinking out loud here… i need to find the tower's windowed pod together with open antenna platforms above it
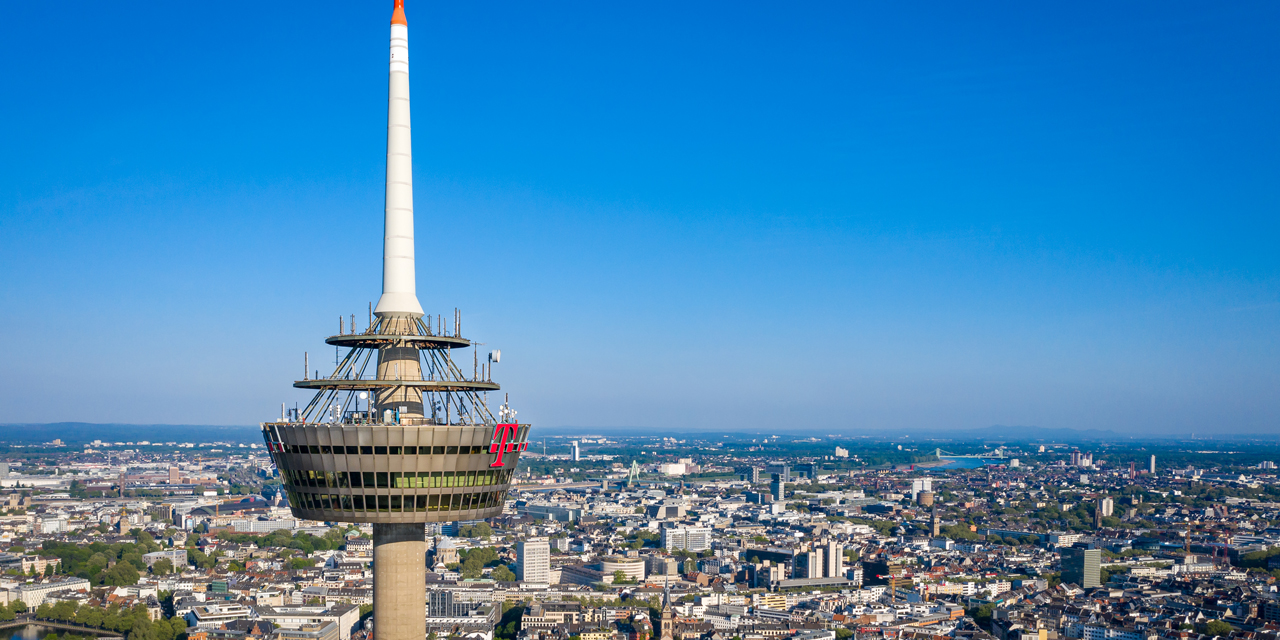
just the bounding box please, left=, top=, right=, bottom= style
left=262, top=311, right=529, bottom=524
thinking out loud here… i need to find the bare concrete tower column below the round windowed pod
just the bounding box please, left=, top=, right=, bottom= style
left=374, top=522, right=426, bottom=640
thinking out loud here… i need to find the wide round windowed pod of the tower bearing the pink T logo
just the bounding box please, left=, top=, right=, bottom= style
left=262, top=422, right=529, bottom=524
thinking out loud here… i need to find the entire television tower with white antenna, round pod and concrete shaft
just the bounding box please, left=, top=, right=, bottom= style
left=262, top=0, right=529, bottom=640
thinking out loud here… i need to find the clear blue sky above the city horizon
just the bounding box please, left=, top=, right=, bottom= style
left=0, top=0, right=1280, bottom=434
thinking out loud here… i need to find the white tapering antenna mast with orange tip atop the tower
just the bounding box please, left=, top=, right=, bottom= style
left=374, top=1, right=422, bottom=317
